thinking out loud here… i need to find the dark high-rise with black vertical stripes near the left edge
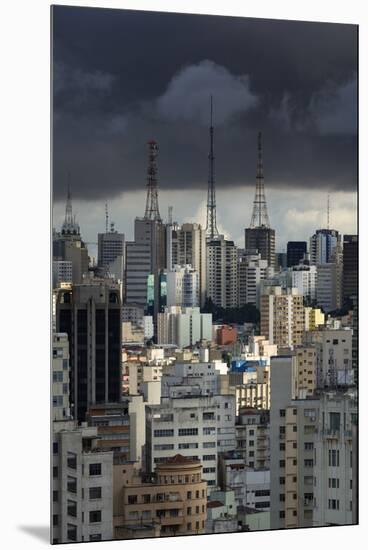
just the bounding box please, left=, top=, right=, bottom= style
left=56, top=279, right=121, bottom=421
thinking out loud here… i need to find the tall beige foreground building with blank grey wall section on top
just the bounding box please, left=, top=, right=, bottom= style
left=270, top=355, right=319, bottom=529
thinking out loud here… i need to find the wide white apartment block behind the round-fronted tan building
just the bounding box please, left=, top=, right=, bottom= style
left=146, top=395, right=235, bottom=490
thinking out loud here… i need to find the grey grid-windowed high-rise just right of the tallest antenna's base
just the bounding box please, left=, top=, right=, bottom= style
left=207, top=235, right=238, bottom=309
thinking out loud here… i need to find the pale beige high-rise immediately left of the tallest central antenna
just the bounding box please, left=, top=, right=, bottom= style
left=167, top=223, right=207, bottom=307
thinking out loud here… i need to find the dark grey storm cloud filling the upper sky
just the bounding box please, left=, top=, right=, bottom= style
left=53, top=7, right=357, bottom=204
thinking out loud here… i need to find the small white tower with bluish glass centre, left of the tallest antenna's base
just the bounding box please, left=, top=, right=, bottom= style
left=165, top=265, right=200, bottom=307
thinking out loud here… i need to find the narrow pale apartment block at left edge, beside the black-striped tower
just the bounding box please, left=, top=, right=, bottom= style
left=52, top=332, right=70, bottom=421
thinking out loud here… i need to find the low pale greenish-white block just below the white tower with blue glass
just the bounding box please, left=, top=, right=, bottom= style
left=157, top=306, right=212, bottom=349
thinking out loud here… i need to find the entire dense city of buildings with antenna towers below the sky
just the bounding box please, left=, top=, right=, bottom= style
left=52, top=119, right=358, bottom=543
